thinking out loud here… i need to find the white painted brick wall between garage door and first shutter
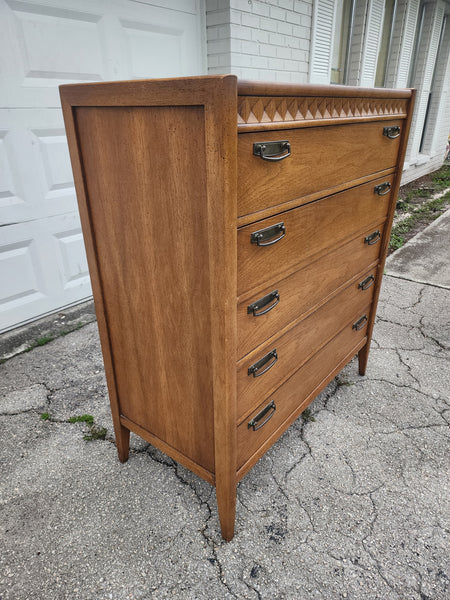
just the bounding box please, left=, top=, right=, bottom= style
left=206, top=0, right=313, bottom=83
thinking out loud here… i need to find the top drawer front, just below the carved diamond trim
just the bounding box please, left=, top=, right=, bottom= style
left=238, top=119, right=403, bottom=216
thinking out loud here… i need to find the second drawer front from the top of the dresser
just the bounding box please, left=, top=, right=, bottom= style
left=237, top=175, right=393, bottom=296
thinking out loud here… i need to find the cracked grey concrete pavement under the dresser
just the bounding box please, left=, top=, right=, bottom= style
left=0, top=213, right=450, bottom=600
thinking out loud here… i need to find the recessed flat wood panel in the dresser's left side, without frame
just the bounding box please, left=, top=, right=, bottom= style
left=75, top=105, right=214, bottom=472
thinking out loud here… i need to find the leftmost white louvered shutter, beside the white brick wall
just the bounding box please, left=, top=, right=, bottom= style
left=309, top=0, right=335, bottom=83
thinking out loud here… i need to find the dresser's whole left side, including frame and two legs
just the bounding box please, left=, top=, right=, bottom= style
left=61, top=76, right=237, bottom=539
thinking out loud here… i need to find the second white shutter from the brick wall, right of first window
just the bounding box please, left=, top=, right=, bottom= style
left=360, top=0, right=384, bottom=87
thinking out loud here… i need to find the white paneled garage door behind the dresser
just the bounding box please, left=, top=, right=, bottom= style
left=0, top=0, right=206, bottom=332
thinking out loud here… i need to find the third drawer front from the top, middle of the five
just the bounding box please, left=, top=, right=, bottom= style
left=237, top=227, right=383, bottom=358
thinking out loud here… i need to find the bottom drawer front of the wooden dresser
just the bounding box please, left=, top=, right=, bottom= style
left=237, top=314, right=366, bottom=469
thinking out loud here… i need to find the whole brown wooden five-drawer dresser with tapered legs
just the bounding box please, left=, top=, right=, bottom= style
left=61, top=75, right=414, bottom=540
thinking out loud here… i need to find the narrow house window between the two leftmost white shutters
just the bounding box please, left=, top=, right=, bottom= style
left=330, top=0, right=354, bottom=84
